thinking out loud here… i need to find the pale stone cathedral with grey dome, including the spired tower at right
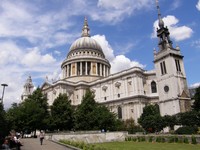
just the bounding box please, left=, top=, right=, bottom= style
left=21, top=6, right=190, bottom=123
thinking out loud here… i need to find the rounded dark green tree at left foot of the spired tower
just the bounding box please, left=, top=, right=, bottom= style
left=138, top=105, right=165, bottom=132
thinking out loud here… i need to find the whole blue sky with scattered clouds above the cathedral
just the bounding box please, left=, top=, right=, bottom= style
left=0, top=0, right=200, bottom=108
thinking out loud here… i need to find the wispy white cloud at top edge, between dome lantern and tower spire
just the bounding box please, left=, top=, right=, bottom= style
left=88, top=0, right=153, bottom=24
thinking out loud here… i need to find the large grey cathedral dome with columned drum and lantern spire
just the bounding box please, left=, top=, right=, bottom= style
left=61, top=19, right=110, bottom=82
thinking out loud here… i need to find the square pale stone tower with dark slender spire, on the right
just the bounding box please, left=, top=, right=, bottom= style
left=154, top=0, right=191, bottom=116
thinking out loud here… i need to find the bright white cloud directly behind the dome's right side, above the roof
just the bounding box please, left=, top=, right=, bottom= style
left=92, top=35, right=145, bottom=73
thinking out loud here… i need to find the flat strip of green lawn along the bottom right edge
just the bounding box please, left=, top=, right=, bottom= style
left=95, top=142, right=200, bottom=150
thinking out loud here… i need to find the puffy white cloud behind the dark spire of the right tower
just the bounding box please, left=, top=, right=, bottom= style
left=152, top=16, right=193, bottom=41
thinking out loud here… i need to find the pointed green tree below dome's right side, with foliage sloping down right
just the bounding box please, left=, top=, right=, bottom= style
left=74, top=90, right=119, bottom=131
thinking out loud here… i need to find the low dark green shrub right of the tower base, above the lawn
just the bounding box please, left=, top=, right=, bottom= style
left=175, top=126, right=198, bottom=134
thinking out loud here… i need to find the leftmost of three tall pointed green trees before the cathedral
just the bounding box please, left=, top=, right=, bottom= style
left=20, top=88, right=49, bottom=134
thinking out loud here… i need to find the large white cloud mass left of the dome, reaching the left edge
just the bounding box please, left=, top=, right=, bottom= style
left=0, top=41, right=60, bottom=108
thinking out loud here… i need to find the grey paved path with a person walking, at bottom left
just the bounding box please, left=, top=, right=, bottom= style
left=20, top=138, right=71, bottom=150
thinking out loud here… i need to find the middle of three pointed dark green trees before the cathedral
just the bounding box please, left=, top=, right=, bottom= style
left=51, top=94, right=73, bottom=130
